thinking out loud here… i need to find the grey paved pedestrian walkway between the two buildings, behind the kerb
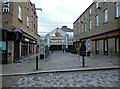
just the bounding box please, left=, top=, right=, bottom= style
left=2, top=52, right=120, bottom=74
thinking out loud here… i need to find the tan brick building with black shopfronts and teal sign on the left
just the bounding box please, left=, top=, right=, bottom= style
left=1, top=0, right=40, bottom=63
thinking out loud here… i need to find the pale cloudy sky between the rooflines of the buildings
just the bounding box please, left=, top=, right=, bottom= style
left=31, top=0, right=93, bottom=35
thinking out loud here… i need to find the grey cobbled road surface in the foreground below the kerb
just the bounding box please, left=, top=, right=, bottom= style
left=13, top=70, right=120, bottom=87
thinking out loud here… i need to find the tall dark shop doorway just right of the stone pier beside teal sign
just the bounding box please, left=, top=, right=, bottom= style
left=14, top=42, right=19, bottom=63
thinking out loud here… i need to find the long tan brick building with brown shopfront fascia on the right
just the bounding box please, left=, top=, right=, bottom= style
left=73, top=1, right=120, bottom=55
